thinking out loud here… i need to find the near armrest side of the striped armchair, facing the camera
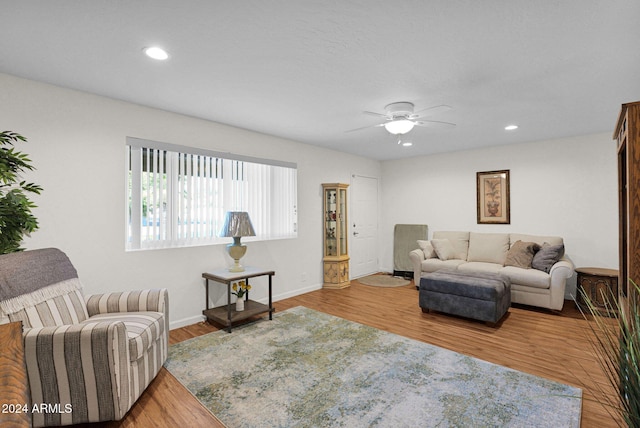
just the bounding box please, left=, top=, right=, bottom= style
left=23, top=321, right=130, bottom=427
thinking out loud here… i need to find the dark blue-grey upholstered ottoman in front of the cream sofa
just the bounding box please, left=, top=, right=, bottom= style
left=419, top=271, right=511, bottom=325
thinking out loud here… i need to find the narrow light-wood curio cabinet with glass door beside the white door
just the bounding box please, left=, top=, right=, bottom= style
left=322, top=183, right=351, bottom=288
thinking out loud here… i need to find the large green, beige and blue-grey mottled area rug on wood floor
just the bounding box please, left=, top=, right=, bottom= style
left=165, top=307, right=582, bottom=428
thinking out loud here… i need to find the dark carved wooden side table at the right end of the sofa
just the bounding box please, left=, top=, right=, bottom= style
left=576, top=267, right=618, bottom=316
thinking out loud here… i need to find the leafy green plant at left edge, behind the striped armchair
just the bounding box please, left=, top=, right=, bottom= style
left=0, top=131, right=42, bottom=254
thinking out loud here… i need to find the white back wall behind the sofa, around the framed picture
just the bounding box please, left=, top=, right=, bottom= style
left=380, top=133, right=618, bottom=297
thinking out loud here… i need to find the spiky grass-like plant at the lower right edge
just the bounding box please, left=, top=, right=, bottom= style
left=580, top=281, right=640, bottom=427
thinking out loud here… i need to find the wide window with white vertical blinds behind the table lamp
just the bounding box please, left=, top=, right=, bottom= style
left=126, top=137, right=297, bottom=250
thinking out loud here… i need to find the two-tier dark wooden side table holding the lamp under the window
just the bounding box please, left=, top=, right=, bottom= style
left=202, top=266, right=276, bottom=333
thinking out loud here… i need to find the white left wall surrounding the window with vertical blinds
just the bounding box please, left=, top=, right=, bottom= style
left=0, top=74, right=380, bottom=327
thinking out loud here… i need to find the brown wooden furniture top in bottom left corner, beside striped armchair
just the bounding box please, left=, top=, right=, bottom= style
left=0, top=322, right=31, bottom=427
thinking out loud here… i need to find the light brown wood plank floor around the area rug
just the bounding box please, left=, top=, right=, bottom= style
left=95, top=281, right=618, bottom=428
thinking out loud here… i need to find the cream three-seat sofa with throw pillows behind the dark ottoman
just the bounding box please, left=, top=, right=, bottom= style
left=409, top=231, right=573, bottom=311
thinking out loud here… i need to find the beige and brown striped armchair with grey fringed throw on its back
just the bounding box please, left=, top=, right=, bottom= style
left=0, top=248, right=169, bottom=427
